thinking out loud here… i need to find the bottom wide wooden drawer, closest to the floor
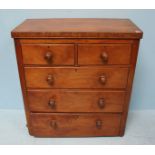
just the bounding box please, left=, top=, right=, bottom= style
left=30, top=113, right=121, bottom=137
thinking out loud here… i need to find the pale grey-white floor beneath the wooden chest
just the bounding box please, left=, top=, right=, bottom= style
left=0, top=110, right=155, bottom=145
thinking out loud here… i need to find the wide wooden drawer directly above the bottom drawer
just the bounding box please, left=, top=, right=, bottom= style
left=27, top=89, right=125, bottom=112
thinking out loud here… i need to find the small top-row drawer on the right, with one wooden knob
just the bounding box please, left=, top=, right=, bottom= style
left=78, top=44, right=131, bottom=65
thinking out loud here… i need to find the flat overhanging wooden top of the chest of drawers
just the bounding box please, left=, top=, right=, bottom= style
left=11, top=18, right=143, bottom=39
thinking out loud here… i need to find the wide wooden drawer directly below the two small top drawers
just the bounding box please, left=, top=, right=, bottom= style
left=25, top=67, right=129, bottom=88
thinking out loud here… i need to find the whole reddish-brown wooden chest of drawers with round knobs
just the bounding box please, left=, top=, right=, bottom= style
left=12, top=19, right=142, bottom=137
